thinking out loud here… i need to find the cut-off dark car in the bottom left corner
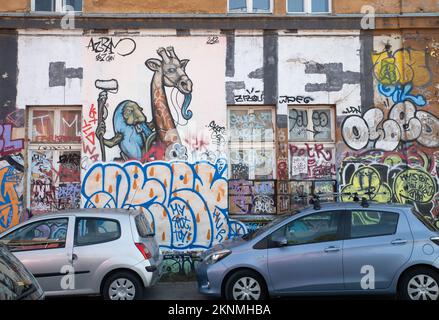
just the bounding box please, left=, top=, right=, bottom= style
left=0, top=245, right=37, bottom=300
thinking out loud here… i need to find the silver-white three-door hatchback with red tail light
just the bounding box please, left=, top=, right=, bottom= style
left=0, top=209, right=163, bottom=300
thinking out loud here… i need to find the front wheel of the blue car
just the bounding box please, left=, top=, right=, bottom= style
left=225, top=270, right=268, bottom=300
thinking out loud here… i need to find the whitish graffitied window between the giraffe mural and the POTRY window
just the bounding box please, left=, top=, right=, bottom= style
left=228, top=106, right=276, bottom=180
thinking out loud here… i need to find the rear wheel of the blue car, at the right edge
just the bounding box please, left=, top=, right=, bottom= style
left=398, top=268, right=439, bottom=300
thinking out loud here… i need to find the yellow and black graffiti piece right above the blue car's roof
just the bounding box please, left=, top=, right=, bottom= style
left=340, top=146, right=438, bottom=213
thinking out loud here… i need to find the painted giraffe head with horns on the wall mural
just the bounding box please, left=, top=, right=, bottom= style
left=145, top=47, right=192, bottom=95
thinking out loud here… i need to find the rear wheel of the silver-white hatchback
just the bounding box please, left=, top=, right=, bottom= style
left=102, top=271, right=143, bottom=300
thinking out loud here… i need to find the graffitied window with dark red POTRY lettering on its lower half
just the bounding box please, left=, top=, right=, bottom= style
left=288, top=106, right=335, bottom=180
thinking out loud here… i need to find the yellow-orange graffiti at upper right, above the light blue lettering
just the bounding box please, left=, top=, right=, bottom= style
left=372, top=48, right=431, bottom=86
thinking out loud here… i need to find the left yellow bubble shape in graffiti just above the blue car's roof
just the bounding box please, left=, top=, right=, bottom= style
left=341, top=167, right=392, bottom=202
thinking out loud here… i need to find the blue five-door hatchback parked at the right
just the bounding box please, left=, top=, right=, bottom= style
left=197, top=202, right=439, bottom=300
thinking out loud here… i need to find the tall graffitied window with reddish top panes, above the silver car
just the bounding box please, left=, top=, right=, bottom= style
left=27, top=106, right=82, bottom=214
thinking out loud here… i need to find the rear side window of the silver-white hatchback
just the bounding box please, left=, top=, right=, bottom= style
left=75, top=218, right=121, bottom=246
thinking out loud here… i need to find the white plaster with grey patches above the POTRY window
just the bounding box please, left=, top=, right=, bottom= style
left=279, top=33, right=361, bottom=115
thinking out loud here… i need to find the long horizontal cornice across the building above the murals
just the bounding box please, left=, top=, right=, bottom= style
left=0, top=13, right=439, bottom=30
